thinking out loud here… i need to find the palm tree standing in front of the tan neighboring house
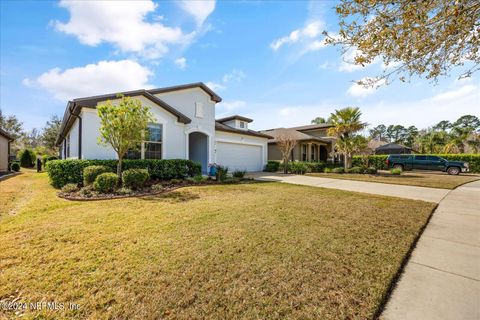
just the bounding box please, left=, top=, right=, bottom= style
left=328, top=107, right=367, bottom=169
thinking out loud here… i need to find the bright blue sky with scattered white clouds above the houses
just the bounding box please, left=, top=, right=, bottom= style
left=0, top=0, right=480, bottom=129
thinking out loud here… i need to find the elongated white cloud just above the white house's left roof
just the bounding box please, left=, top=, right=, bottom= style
left=23, top=60, right=152, bottom=101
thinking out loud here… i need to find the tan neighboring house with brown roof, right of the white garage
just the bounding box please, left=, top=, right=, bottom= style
left=261, top=123, right=335, bottom=161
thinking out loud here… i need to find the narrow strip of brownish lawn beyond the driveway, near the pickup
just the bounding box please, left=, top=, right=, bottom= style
left=308, top=171, right=480, bottom=189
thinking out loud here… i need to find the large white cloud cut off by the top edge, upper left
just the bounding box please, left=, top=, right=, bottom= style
left=54, top=0, right=195, bottom=59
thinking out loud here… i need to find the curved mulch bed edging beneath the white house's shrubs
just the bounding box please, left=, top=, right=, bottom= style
left=57, top=179, right=255, bottom=201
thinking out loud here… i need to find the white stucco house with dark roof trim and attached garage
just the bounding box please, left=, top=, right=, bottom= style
left=56, top=83, right=270, bottom=173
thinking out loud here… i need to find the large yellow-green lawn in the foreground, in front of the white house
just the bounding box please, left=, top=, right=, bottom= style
left=0, top=172, right=434, bottom=319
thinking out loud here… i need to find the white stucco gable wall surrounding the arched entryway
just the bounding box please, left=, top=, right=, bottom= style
left=155, top=88, right=215, bottom=163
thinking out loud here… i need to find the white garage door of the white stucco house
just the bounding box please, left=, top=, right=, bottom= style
left=217, top=142, right=263, bottom=171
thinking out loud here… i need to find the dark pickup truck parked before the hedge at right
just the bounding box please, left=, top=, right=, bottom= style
left=386, top=154, right=469, bottom=175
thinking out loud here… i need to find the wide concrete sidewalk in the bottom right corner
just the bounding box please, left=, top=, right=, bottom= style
left=381, top=181, right=480, bottom=320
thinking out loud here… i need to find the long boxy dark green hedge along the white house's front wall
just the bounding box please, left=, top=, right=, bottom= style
left=47, top=159, right=202, bottom=189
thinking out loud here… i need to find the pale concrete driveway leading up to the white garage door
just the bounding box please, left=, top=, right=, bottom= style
left=248, top=172, right=450, bottom=203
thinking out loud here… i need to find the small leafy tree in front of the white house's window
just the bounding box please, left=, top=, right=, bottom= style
left=97, top=96, right=153, bottom=177
